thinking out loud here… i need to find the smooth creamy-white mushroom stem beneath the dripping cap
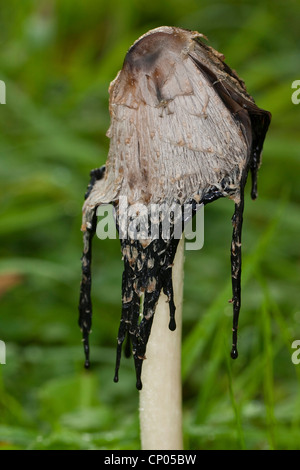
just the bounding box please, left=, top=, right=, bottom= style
left=140, top=238, right=184, bottom=450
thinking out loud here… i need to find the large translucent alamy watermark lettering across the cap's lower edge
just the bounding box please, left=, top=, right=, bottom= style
left=96, top=196, right=204, bottom=250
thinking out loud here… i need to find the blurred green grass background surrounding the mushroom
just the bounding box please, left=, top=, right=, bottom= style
left=0, top=0, right=300, bottom=450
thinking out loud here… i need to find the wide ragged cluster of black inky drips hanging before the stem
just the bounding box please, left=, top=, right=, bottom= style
left=114, top=213, right=179, bottom=390
